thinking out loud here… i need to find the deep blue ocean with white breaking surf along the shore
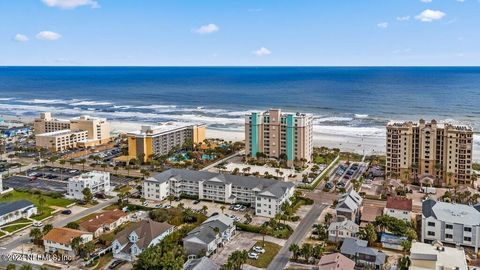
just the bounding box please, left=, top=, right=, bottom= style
left=0, top=67, right=480, bottom=158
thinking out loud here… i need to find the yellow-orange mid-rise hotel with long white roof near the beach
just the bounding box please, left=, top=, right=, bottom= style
left=127, top=124, right=205, bottom=161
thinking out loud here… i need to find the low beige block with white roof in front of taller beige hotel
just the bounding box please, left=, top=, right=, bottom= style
left=35, top=129, right=88, bottom=152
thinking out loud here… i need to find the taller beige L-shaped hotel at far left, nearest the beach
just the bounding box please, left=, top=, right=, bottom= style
left=33, top=112, right=110, bottom=146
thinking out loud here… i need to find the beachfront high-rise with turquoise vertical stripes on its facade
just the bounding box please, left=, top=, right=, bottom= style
left=245, top=109, right=313, bottom=165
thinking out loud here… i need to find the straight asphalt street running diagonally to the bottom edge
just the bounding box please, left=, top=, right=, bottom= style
left=267, top=204, right=327, bottom=270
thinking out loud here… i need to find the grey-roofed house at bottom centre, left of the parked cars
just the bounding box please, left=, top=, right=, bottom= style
left=183, top=214, right=235, bottom=256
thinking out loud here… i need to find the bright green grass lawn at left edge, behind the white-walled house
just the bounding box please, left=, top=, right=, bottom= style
left=0, top=190, right=73, bottom=220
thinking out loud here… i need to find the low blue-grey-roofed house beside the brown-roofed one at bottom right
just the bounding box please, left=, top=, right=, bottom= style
left=340, top=238, right=387, bottom=269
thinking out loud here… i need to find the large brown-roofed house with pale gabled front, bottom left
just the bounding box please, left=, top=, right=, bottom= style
left=112, top=220, right=175, bottom=261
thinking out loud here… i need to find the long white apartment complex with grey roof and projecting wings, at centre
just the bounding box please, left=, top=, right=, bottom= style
left=143, top=169, right=295, bottom=217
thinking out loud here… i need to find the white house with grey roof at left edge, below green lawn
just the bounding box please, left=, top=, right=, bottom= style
left=0, top=199, right=37, bottom=226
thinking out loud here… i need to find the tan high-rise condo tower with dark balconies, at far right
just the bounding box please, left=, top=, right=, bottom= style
left=386, top=119, right=473, bottom=186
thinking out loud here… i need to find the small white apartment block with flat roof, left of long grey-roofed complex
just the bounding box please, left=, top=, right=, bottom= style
left=66, top=171, right=110, bottom=200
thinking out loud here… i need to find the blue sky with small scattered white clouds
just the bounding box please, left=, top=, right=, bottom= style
left=0, top=0, right=480, bottom=66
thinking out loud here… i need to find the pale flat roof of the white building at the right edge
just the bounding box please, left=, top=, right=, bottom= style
left=422, top=199, right=480, bottom=226
